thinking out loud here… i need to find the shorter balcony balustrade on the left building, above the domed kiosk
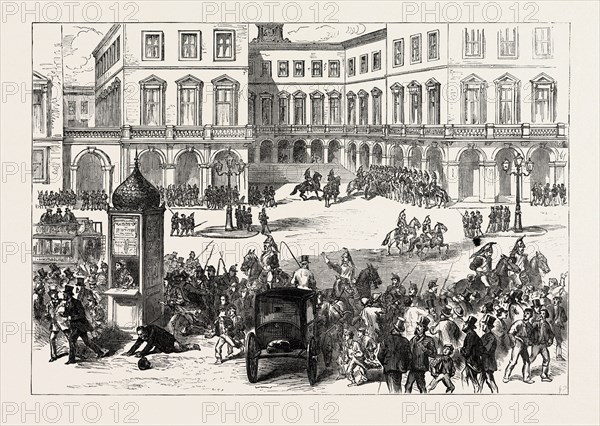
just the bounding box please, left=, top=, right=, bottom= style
left=64, top=125, right=253, bottom=142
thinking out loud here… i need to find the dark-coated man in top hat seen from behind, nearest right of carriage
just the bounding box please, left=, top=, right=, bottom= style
left=377, top=317, right=412, bottom=393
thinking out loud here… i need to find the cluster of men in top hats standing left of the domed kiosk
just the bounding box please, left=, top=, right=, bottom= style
left=33, top=262, right=108, bottom=364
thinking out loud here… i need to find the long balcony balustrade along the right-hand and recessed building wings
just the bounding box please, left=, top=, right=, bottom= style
left=254, top=123, right=567, bottom=140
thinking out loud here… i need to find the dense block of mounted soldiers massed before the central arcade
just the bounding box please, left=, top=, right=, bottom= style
left=348, top=165, right=450, bottom=207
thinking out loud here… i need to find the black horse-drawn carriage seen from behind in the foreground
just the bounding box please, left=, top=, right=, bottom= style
left=245, top=287, right=331, bottom=385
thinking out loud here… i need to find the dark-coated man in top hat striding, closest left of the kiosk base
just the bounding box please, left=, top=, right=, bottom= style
left=63, top=285, right=108, bottom=364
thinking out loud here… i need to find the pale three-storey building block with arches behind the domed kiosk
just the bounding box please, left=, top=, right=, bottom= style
left=64, top=23, right=252, bottom=200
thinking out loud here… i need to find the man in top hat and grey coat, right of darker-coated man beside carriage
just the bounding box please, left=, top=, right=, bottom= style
left=404, top=317, right=437, bottom=393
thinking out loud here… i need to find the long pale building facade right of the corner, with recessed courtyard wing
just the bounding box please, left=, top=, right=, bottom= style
left=248, top=23, right=570, bottom=202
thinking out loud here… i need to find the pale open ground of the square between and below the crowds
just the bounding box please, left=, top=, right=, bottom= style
left=33, top=185, right=568, bottom=394
